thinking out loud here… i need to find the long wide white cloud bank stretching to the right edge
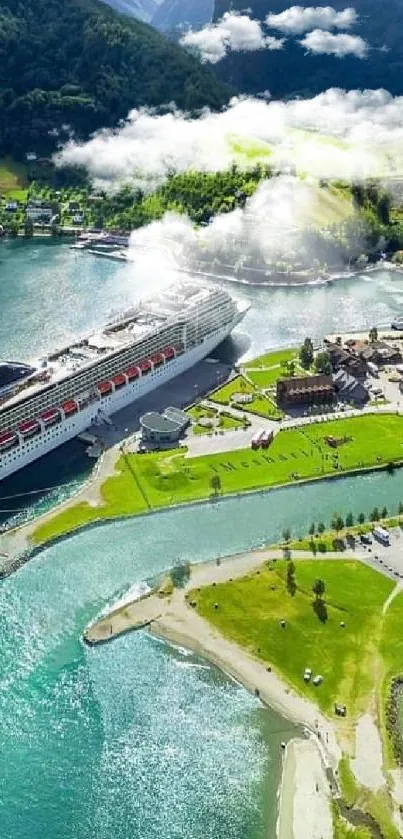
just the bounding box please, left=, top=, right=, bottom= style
left=57, top=89, right=403, bottom=190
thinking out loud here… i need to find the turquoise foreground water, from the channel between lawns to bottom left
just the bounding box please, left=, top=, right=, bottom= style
left=0, top=472, right=403, bottom=839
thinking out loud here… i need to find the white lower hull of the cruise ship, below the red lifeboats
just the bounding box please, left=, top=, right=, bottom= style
left=0, top=313, right=243, bottom=480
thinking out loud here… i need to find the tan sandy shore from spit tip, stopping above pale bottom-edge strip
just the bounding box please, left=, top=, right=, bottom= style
left=83, top=548, right=346, bottom=770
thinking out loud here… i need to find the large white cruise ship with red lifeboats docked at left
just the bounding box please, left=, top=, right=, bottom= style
left=0, top=280, right=249, bottom=480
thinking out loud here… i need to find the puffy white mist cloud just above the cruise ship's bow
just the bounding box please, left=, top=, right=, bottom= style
left=124, top=175, right=365, bottom=288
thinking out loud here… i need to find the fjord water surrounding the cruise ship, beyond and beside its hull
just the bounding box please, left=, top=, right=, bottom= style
left=0, top=239, right=403, bottom=524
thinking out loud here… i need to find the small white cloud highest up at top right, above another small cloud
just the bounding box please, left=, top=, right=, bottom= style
left=266, top=6, right=357, bottom=35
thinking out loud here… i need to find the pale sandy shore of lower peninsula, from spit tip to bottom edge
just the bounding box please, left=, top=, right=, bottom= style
left=84, top=550, right=344, bottom=839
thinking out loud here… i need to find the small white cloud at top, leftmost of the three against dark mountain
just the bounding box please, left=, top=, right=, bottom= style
left=181, top=12, right=283, bottom=64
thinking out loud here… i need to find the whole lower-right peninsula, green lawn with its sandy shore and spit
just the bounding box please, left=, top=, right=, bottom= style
left=85, top=549, right=403, bottom=839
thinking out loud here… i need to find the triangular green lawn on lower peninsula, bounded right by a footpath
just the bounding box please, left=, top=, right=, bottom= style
left=193, top=560, right=394, bottom=720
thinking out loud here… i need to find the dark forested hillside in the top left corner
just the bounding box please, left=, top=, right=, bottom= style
left=0, top=0, right=229, bottom=157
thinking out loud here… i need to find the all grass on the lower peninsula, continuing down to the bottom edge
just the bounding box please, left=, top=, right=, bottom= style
left=190, top=559, right=403, bottom=839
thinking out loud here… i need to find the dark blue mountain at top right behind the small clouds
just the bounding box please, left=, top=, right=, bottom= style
left=215, top=0, right=403, bottom=98
